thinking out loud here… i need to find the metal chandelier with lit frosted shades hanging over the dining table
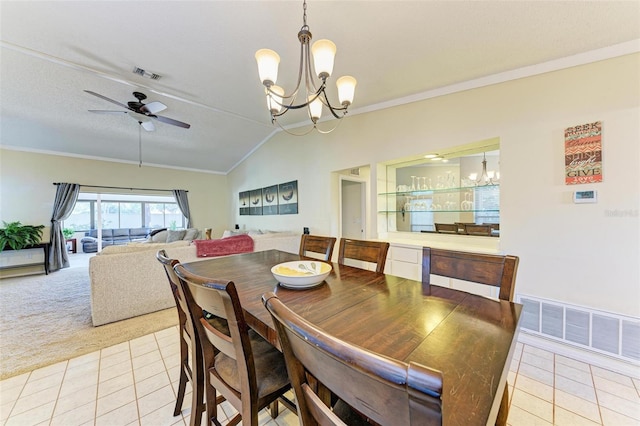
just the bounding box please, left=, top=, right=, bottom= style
left=256, top=0, right=356, bottom=136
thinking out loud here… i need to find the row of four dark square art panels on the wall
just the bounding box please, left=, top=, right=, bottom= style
left=238, top=180, right=298, bottom=216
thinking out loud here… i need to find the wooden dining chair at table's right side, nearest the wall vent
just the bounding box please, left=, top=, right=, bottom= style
left=422, top=247, right=520, bottom=425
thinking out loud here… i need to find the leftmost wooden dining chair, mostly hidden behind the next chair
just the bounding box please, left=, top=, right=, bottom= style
left=156, top=250, right=205, bottom=425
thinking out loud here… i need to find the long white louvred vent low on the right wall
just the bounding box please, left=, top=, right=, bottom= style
left=517, top=295, right=640, bottom=363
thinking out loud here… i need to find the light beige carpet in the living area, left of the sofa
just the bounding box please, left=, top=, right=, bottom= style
left=0, top=267, right=178, bottom=379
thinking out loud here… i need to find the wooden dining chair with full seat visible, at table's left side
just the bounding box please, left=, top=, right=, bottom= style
left=174, top=264, right=296, bottom=426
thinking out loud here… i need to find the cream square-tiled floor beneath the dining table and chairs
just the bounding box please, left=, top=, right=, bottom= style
left=0, top=327, right=640, bottom=426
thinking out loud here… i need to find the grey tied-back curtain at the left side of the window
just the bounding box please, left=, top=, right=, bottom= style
left=49, top=183, right=80, bottom=271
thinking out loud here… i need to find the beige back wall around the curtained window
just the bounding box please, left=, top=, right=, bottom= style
left=0, top=150, right=230, bottom=239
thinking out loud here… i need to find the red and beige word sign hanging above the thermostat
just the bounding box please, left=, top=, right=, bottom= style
left=564, top=121, right=602, bottom=185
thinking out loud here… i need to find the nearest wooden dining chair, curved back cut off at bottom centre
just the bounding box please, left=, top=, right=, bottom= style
left=262, top=292, right=442, bottom=426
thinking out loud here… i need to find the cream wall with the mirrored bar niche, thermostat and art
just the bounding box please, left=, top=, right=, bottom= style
left=229, top=54, right=640, bottom=317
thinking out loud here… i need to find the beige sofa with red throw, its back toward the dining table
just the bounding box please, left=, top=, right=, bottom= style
left=89, top=232, right=300, bottom=326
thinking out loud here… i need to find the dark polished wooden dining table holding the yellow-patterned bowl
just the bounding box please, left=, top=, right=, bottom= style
left=183, top=250, right=522, bottom=426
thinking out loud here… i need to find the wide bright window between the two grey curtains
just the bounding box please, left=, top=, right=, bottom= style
left=64, top=193, right=185, bottom=231
